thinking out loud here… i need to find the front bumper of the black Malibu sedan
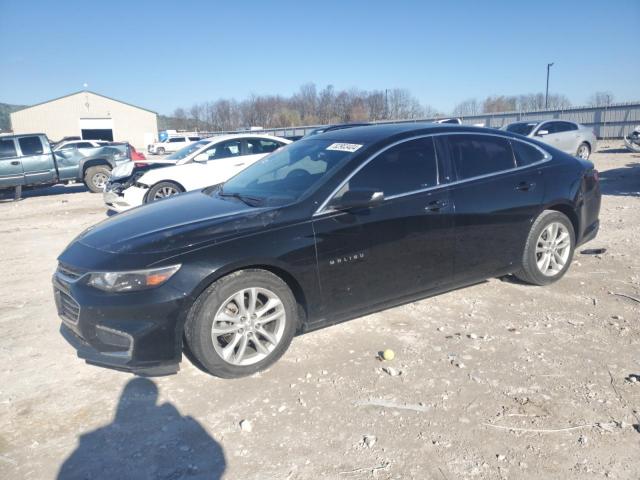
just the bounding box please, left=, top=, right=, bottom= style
left=52, top=266, right=188, bottom=375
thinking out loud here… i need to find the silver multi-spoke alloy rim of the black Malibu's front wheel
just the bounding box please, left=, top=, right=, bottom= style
left=211, top=287, right=286, bottom=366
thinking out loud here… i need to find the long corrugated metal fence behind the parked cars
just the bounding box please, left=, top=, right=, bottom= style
left=211, top=103, right=640, bottom=138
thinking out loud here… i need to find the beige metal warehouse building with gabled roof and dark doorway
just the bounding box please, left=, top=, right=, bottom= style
left=11, top=90, right=158, bottom=149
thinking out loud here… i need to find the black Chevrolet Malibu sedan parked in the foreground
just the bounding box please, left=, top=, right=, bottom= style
left=53, top=123, right=600, bottom=378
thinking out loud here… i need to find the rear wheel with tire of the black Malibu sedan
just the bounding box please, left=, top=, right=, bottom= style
left=516, top=210, right=575, bottom=285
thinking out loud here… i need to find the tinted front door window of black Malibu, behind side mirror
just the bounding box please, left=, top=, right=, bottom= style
left=337, top=137, right=438, bottom=197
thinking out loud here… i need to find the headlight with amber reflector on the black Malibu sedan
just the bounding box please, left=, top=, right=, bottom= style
left=88, top=265, right=180, bottom=292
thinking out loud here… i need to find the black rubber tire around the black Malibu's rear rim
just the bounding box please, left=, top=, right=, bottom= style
left=515, top=210, right=576, bottom=286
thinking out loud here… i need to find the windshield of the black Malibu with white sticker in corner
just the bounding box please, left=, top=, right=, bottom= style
left=218, top=139, right=362, bottom=205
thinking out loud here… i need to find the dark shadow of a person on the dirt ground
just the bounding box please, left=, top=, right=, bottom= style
left=58, top=378, right=226, bottom=480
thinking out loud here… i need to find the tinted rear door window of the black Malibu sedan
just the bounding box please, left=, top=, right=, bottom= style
left=440, top=134, right=515, bottom=180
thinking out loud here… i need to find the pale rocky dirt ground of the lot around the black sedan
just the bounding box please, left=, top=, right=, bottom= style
left=0, top=142, right=640, bottom=480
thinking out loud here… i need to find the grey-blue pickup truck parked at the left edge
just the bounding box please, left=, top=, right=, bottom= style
left=0, top=134, right=139, bottom=192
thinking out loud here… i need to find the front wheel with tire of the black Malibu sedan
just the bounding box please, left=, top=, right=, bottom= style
left=184, top=269, right=297, bottom=378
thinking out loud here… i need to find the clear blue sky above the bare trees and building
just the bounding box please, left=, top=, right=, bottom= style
left=0, top=0, right=640, bottom=113
